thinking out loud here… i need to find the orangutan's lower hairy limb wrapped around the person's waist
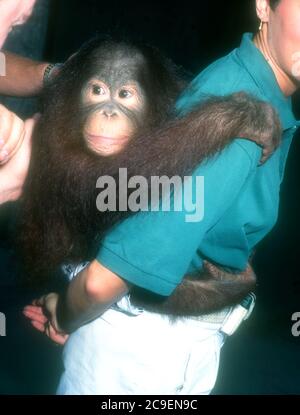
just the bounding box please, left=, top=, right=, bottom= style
left=130, top=261, right=256, bottom=319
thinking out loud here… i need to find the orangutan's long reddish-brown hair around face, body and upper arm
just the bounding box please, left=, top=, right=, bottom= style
left=19, top=40, right=280, bottom=290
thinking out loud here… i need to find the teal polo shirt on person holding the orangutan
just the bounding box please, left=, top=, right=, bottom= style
left=97, top=34, right=299, bottom=296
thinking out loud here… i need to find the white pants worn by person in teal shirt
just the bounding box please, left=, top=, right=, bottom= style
left=57, top=296, right=230, bottom=395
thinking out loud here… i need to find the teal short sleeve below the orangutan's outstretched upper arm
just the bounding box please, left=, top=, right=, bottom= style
left=96, top=139, right=261, bottom=296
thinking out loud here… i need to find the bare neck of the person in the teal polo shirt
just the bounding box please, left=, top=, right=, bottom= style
left=253, top=28, right=298, bottom=97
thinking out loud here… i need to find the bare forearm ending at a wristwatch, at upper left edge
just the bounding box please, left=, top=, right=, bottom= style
left=0, top=52, right=48, bottom=96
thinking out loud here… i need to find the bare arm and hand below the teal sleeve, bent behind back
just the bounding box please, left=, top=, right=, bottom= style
left=24, top=261, right=129, bottom=338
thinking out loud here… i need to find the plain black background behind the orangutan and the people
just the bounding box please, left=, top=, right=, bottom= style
left=0, top=0, right=300, bottom=394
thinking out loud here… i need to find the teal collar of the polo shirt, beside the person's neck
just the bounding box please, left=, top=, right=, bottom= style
left=236, top=33, right=300, bottom=130
